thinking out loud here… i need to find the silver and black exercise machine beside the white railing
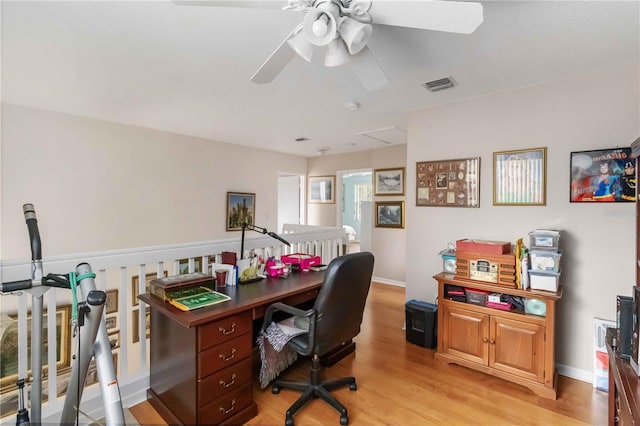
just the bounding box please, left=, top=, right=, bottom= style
left=0, top=204, right=125, bottom=426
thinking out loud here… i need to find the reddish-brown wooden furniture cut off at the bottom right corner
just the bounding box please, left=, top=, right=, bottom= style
left=607, top=328, right=640, bottom=426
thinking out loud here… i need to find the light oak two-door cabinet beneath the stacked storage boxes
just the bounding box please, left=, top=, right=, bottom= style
left=434, top=273, right=562, bottom=399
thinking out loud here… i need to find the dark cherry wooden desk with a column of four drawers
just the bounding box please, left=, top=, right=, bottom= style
left=139, top=272, right=324, bottom=425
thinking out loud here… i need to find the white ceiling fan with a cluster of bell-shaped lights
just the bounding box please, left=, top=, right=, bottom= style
left=175, top=0, right=484, bottom=91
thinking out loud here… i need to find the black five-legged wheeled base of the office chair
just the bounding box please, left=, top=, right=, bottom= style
left=271, top=357, right=358, bottom=426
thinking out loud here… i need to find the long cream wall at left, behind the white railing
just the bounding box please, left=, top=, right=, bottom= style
left=0, top=104, right=306, bottom=260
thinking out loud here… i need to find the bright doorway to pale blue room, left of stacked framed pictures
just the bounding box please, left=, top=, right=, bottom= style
left=336, top=170, right=373, bottom=253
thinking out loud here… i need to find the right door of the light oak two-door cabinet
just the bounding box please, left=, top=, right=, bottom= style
left=489, top=317, right=544, bottom=383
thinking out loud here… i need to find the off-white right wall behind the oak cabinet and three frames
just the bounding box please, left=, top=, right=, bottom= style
left=406, top=62, right=640, bottom=379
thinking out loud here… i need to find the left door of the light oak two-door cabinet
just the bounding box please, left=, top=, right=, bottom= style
left=443, top=305, right=489, bottom=365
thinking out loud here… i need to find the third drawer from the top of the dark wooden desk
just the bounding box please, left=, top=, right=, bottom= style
left=198, top=358, right=253, bottom=407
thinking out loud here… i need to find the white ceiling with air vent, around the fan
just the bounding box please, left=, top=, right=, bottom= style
left=1, top=0, right=640, bottom=156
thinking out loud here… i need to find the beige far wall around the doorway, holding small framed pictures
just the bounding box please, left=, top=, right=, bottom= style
left=307, top=145, right=410, bottom=284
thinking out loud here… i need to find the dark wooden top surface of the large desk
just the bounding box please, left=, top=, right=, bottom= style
left=139, top=271, right=324, bottom=327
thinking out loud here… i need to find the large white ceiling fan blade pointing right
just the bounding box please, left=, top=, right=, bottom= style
left=369, top=0, right=484, bottom=34
